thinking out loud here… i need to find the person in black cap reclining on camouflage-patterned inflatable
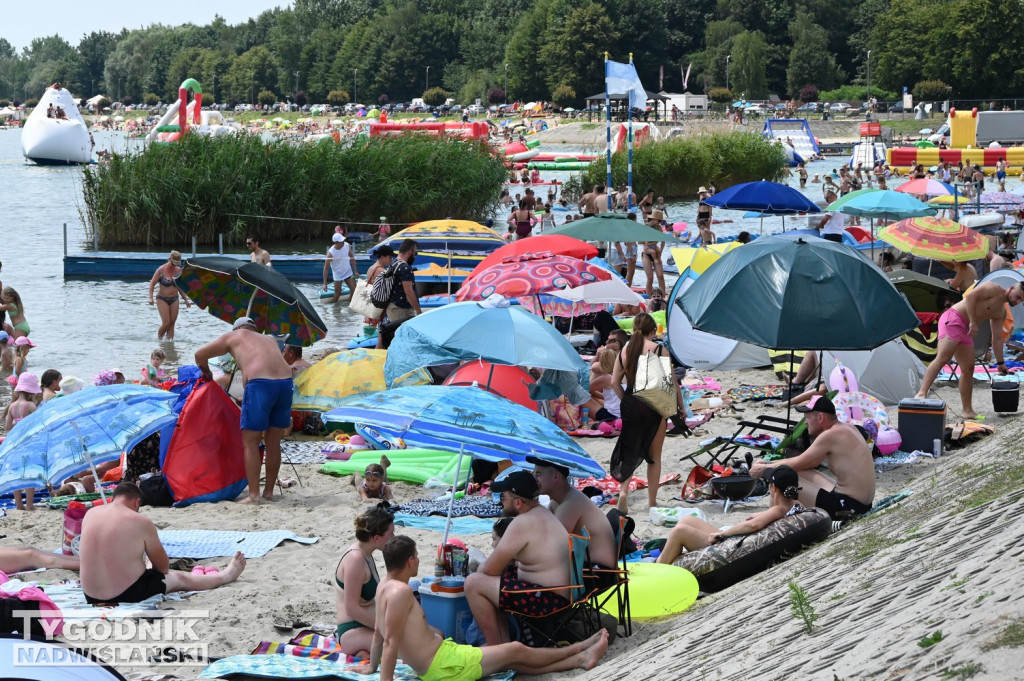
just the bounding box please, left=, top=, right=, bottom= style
left=657, top=466, right=804, bottom=564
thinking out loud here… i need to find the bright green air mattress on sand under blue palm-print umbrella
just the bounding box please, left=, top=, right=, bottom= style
left=319, top=450, right=472, bottom=486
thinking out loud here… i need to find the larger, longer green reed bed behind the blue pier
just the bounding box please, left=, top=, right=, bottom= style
left=83, top=135, right=505, bottom=246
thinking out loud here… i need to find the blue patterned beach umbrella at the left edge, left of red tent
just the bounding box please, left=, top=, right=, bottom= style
left=0, top=384, right=178, bottom=494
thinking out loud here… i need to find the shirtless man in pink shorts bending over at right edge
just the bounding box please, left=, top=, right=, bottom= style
left=914, top=282, right=1024, bottom=419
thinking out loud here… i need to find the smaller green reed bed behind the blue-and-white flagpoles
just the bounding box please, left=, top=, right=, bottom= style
left=563, top=132, right=785, bottom=201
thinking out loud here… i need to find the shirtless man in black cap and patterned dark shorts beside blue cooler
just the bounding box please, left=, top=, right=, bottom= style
left=466, top=471, right=569, bottom=645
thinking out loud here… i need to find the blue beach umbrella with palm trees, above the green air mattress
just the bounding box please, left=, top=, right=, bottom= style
left=324, top=385, right=605, bottom=478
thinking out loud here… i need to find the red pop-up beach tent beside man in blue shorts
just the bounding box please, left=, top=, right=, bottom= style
left=160, top=382, right=248, bottom=506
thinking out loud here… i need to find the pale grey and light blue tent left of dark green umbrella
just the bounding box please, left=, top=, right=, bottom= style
left=666, top=268, right=771, bottom=371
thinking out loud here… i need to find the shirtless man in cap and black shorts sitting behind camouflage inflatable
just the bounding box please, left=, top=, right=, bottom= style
left=751, top=395, right=874, bottom=520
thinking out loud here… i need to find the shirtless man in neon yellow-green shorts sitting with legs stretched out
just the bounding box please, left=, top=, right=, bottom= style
left=348, top=536, right=608, bottom=681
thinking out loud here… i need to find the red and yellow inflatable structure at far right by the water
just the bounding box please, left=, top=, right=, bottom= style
left=887, top=109, right=1024, bottom=175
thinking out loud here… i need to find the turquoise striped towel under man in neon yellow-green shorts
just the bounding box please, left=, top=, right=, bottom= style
left=199, top=655, right=515, bottom=681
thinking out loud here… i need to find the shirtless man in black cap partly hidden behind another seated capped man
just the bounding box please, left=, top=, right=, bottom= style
left=526, top=457, right=618, bottom=586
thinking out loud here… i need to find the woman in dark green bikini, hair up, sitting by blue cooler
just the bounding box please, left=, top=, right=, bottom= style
left=334, top=506, right=394, bottom=658
